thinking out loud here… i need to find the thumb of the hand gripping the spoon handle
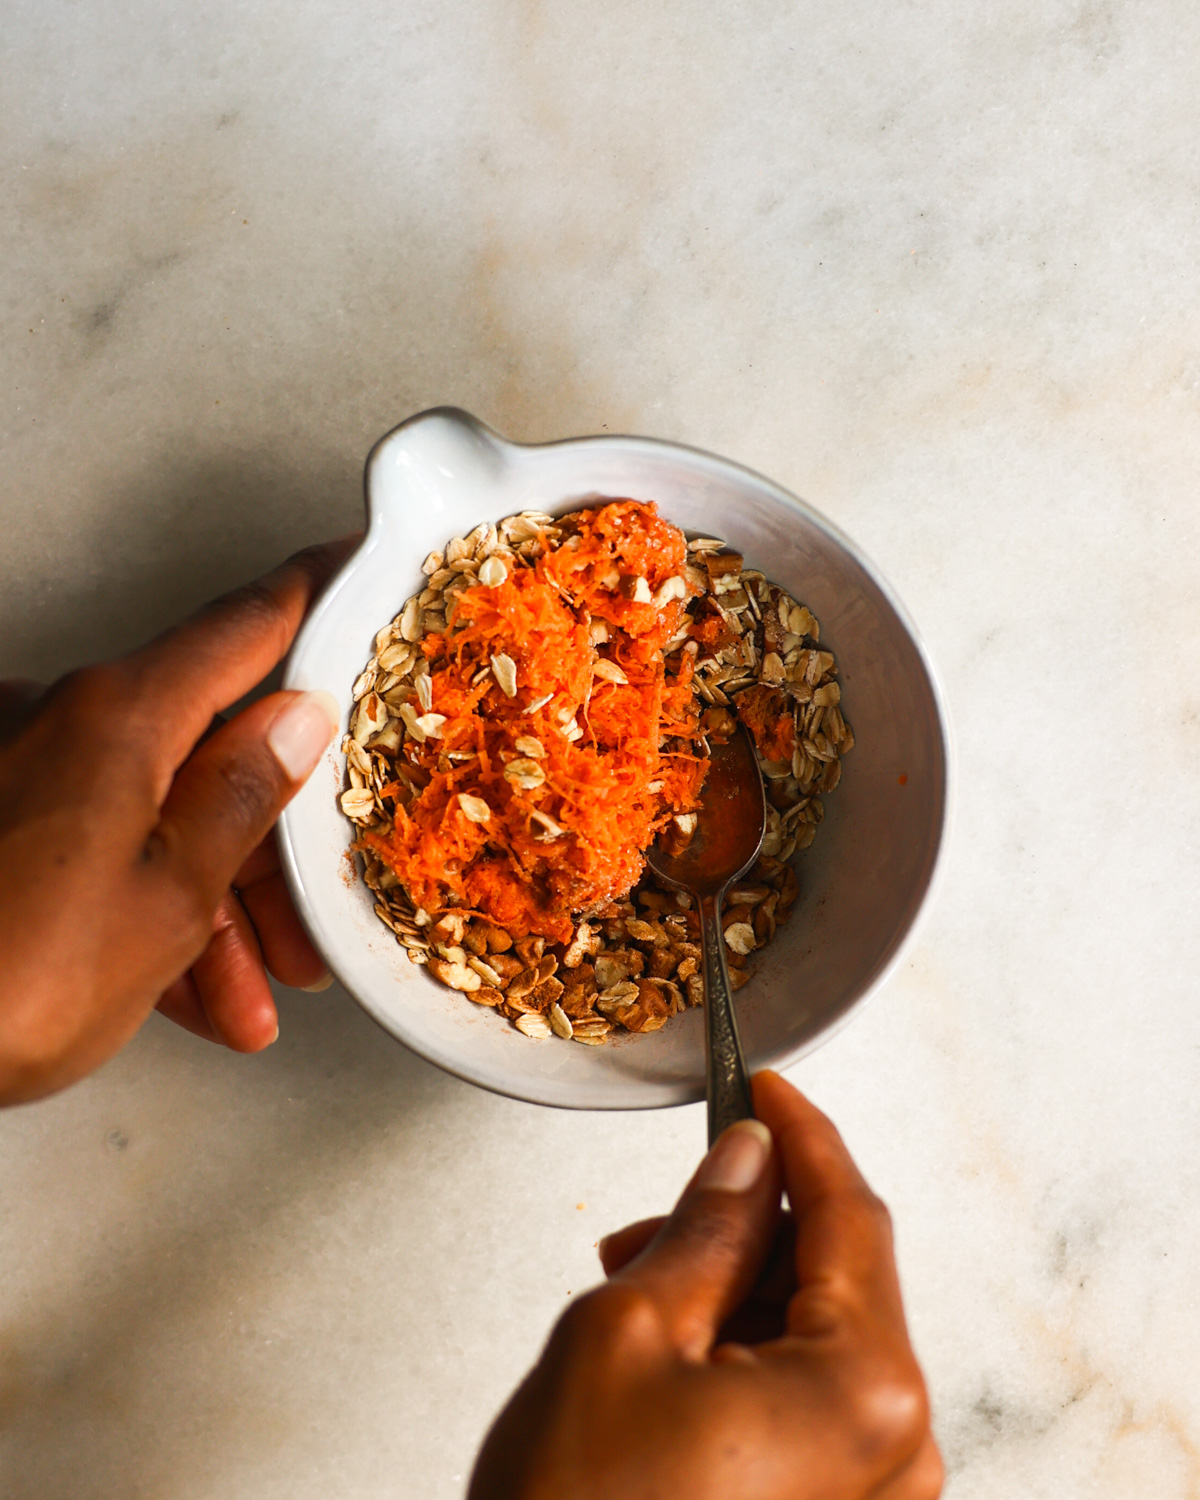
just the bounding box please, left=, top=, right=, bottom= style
left=612, top=1121, right=780, bottom=1359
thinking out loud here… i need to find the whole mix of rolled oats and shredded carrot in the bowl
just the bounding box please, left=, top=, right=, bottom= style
left=333, top=501, right=854, bottom=1046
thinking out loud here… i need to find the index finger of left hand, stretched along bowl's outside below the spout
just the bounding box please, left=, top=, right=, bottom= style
left=125, top=536, right=359, bottom=776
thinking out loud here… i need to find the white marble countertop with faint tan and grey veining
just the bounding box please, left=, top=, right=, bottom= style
left=0, top=0, right=1200, bottom=1500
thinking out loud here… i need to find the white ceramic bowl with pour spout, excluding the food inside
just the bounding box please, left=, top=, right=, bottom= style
left=281, top=408, right=950, bottom=1109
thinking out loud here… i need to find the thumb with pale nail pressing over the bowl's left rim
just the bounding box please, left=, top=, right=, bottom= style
left=144, top=693, right=338, bottom=924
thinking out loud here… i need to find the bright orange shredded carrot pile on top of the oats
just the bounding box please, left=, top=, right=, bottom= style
left=362, top=501, right=708, bottom=942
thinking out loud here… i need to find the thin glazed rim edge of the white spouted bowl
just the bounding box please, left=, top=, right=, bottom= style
left=276, top=405, right=957, bottom=1112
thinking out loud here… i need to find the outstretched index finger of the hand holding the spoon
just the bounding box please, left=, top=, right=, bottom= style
left=753, top=1073, right=903, bottom=1334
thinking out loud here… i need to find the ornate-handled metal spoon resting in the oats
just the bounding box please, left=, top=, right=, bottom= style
left=647, top=726, right=767, bottom=1146
